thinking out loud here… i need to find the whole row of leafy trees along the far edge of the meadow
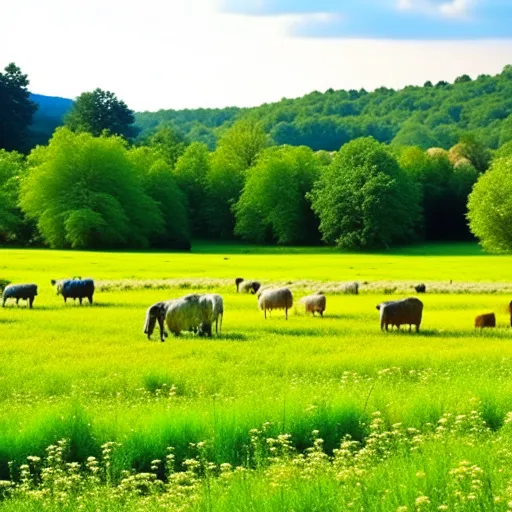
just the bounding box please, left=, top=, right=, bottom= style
left=0, top=65, right=512, bottom=251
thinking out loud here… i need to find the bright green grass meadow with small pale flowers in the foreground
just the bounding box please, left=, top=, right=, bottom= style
left=0, top=244, right=512, bottom=511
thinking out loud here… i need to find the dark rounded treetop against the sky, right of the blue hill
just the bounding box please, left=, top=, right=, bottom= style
left=65, top=89, right=135, bottom=139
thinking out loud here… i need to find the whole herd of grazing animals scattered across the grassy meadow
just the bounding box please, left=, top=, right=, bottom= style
left=2, top=277, right=512, bottom=341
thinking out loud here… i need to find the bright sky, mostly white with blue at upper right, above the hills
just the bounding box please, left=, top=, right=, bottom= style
left=0, top=0, right=512, bottom=111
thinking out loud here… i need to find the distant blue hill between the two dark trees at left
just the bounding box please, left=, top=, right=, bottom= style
left=29, top=94, right=73, bottom=147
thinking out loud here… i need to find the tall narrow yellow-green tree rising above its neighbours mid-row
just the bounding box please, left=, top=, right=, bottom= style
left=206, top=120, right=268, bottom=238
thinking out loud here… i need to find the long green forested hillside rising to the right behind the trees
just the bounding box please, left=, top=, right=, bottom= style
left=136, top=66, right=512, bottom=151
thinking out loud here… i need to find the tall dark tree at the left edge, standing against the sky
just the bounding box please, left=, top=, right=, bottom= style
left=0, top=62, right=37, bottom=151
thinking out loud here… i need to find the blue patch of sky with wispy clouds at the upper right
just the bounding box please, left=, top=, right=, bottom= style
left=223, top=0, right=512, bottom=40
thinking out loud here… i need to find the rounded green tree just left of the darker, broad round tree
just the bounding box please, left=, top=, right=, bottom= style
left=234, top=146, right=321, bottom=244
